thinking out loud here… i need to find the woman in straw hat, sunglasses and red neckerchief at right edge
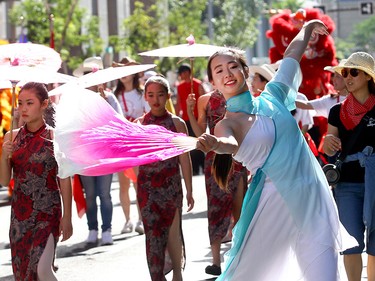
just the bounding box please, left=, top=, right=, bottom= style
left=323, top=52, right=375, bottom=281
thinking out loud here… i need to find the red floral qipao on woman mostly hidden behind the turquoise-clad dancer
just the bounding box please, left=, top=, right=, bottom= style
left=204, top=91, right=247, bottom=243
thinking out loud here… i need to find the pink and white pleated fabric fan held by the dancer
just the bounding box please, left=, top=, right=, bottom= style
left=54, top=87, right=197, bottom=178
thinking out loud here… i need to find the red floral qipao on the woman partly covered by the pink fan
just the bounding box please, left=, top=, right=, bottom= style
left=137, top=112, right=185, bottom=281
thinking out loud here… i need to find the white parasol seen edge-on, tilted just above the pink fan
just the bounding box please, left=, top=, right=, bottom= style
left=48, top=64, right=156, bottom=96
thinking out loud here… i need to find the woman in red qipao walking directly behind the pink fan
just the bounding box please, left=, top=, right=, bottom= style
left=136, top=76, right=194, bottom=281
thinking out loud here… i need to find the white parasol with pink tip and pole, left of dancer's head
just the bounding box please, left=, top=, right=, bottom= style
left=139, top=35, right=224, bottom=92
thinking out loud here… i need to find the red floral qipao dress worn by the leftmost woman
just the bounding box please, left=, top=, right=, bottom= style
left=9, top=125, right=61, bottom=281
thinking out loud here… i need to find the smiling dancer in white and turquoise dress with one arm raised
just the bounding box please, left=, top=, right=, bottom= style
left=197, top=20, right=355, bottom=281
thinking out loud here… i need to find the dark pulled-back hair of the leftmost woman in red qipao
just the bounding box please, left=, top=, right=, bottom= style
left=19, top=82, right=56, bottom=127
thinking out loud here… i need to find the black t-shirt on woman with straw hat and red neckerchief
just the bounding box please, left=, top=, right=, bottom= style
left=328, top=104, right=375, bottom=182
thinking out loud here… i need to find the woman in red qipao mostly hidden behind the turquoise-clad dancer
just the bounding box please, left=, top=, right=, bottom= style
left=186, top=90, right=247, bottom=275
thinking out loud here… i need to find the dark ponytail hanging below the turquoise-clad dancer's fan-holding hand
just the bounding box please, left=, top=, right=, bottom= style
left=212, top=154, right=233, bottom=192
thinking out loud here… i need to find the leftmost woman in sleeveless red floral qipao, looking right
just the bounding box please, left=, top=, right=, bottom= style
left=0, top=82, right=73, bottom=281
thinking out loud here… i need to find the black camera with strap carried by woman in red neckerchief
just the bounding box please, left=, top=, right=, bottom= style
left=322, top=114, right=370, bottom=186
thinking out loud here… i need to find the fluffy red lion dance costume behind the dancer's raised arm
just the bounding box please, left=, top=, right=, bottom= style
left=266, top=8, right=337, bottom=149
